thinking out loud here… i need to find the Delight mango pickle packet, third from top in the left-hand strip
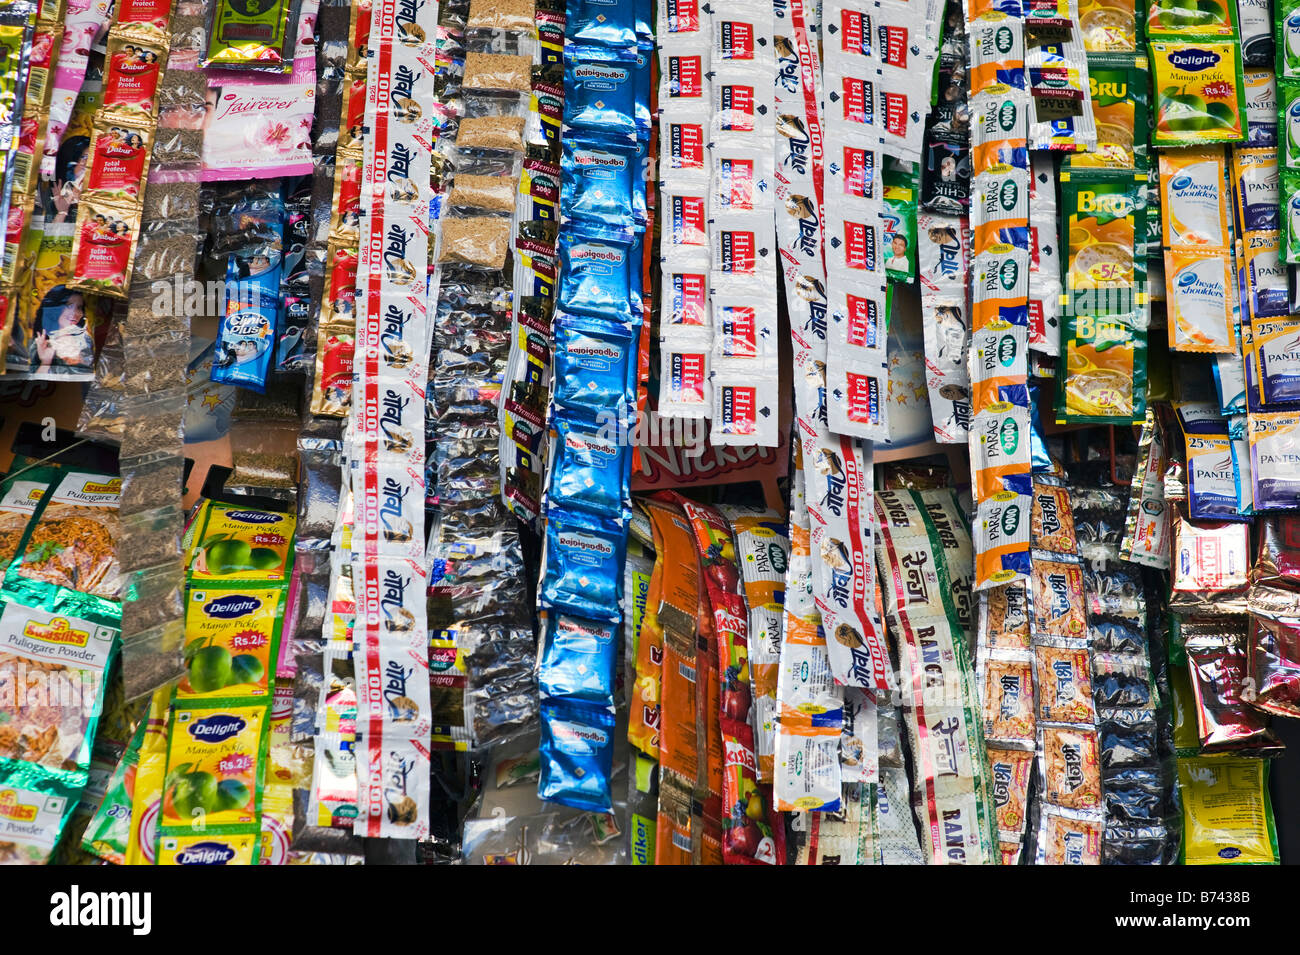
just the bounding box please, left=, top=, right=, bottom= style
left=161, top=706, right=267, bottom=835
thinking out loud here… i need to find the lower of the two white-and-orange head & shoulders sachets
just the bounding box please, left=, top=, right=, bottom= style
left=1165, top=248, right=1236, bottom=355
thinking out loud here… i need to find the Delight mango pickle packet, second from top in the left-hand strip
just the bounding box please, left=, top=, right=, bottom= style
left=176, top=585, right=283, bottom=703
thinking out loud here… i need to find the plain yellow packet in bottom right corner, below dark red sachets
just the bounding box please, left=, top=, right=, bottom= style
left=1178, top=756, right=1279, bottom=865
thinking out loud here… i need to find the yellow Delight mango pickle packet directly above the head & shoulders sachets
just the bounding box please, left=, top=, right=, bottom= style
left=1151, top=36, right=1247, bottom=147
